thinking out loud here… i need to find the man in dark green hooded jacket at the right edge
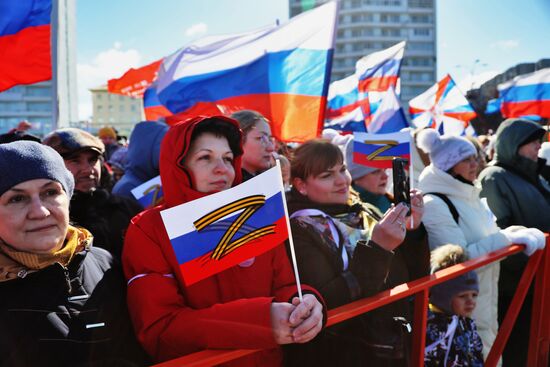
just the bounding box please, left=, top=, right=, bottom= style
left=479, top=119, right=550, bottom=367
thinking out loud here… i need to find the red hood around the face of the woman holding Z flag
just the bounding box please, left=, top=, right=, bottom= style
left=160, top=116, right=242, bottom=208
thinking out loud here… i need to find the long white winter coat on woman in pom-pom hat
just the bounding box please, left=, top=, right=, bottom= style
left=419, top=164, right=510, bottom=357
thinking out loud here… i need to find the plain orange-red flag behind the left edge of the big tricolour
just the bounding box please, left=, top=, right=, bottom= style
left=107, top=59, right=162, bottom=98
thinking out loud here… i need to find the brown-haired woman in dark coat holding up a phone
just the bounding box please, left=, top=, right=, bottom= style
left=288, top=140, right=429, bottom=366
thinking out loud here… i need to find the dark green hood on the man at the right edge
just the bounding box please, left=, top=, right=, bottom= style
left=495, top=119, right=544, bottom=166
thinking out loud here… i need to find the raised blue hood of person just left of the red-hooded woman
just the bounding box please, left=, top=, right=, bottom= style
left=125, top=121, right=168, bottom=183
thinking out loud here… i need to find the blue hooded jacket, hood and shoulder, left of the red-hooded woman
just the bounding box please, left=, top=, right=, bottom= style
left=113, top=121, right=168, bottom=200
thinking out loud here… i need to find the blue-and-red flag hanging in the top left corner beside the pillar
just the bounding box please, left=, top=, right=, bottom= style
left=0, top=0, right=52, bottom=91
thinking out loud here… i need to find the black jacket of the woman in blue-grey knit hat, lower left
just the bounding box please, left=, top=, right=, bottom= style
left=0, top=239, right=145, bottom=367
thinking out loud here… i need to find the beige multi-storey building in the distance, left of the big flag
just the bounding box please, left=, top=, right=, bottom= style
left=90, top=85, right=144, bottom=136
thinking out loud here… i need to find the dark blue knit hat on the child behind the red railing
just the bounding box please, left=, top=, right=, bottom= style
left=430, top=271, right=479, bottom=315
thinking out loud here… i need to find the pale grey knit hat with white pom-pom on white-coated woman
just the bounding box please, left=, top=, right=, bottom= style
left=416, top=129, right=477, bottom=172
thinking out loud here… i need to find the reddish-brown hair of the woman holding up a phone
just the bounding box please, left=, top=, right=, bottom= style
left=290, top=139, right=344, bottom=180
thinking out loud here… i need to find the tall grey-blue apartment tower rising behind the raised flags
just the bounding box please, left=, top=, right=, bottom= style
left=289, top=0, right=436, bottom=102
